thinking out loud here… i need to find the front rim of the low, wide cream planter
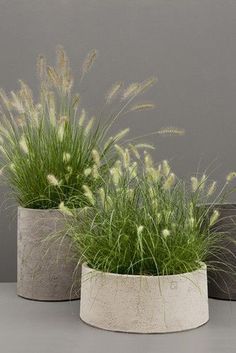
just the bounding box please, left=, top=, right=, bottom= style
left=82, top=262, right=207, bottom=279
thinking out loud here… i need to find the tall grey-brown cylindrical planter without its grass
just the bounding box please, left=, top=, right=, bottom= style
left=17, top=207, right=80, bottom=301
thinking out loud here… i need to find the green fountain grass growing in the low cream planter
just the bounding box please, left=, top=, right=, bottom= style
left=68, top=146, right=236, bottom=275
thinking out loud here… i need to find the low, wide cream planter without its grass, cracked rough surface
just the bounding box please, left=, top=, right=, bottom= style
left=80, top=264, right=209, bottom=333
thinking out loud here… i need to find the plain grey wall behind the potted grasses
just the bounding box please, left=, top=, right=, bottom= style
left=0, top=0, right=236, bottom=281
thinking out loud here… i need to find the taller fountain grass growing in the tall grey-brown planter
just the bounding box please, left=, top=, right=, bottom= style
left=0, top=47, right=182, bottom=209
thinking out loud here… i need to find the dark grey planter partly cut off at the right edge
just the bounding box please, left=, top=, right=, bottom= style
left=208, top=204, right=236, bottom=300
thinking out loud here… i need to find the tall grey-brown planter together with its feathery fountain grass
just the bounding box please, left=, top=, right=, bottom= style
left=0, top=47, right=173, bottom=300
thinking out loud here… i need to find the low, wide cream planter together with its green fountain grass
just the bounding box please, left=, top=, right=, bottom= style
left=70, top=151, right=233, bottom=332
